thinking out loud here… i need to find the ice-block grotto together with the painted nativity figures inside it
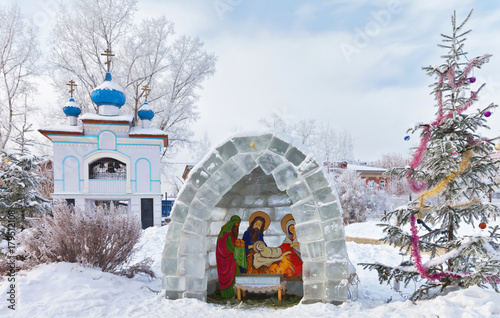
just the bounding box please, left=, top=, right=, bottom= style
left=162, top=132, right=357, bottom=303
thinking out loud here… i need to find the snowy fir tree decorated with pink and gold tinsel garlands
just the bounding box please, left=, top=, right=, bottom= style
left=362, top=11, right=500, bottom=300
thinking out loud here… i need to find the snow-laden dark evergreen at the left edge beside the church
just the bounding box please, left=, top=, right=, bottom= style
left=0, top=151, right=48, bottom=229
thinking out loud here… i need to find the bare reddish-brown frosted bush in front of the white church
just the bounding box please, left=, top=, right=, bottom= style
left=17, top=202, right=141, bottom=272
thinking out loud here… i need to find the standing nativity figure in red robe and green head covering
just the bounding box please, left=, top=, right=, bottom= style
left=215, top=215, right=246, bottom=297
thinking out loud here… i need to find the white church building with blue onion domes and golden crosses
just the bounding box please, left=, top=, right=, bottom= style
left=39, top=51, right=168, bottom=228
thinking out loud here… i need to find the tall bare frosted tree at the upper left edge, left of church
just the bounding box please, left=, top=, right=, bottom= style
left=0, top=3, right=40, bottom=149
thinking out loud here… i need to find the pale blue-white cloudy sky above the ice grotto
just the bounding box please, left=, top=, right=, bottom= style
left=16, top=0, right=500, bottom=161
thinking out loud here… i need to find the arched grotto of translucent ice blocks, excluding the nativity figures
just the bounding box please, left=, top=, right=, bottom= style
left=161, top=132, right=349, bottom=302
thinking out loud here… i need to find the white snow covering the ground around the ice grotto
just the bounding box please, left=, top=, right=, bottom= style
left=0, top=220, right=500, bottom=318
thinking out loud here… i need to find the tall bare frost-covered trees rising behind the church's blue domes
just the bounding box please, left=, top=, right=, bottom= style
left=49, top=0, right=216, bottom=154
